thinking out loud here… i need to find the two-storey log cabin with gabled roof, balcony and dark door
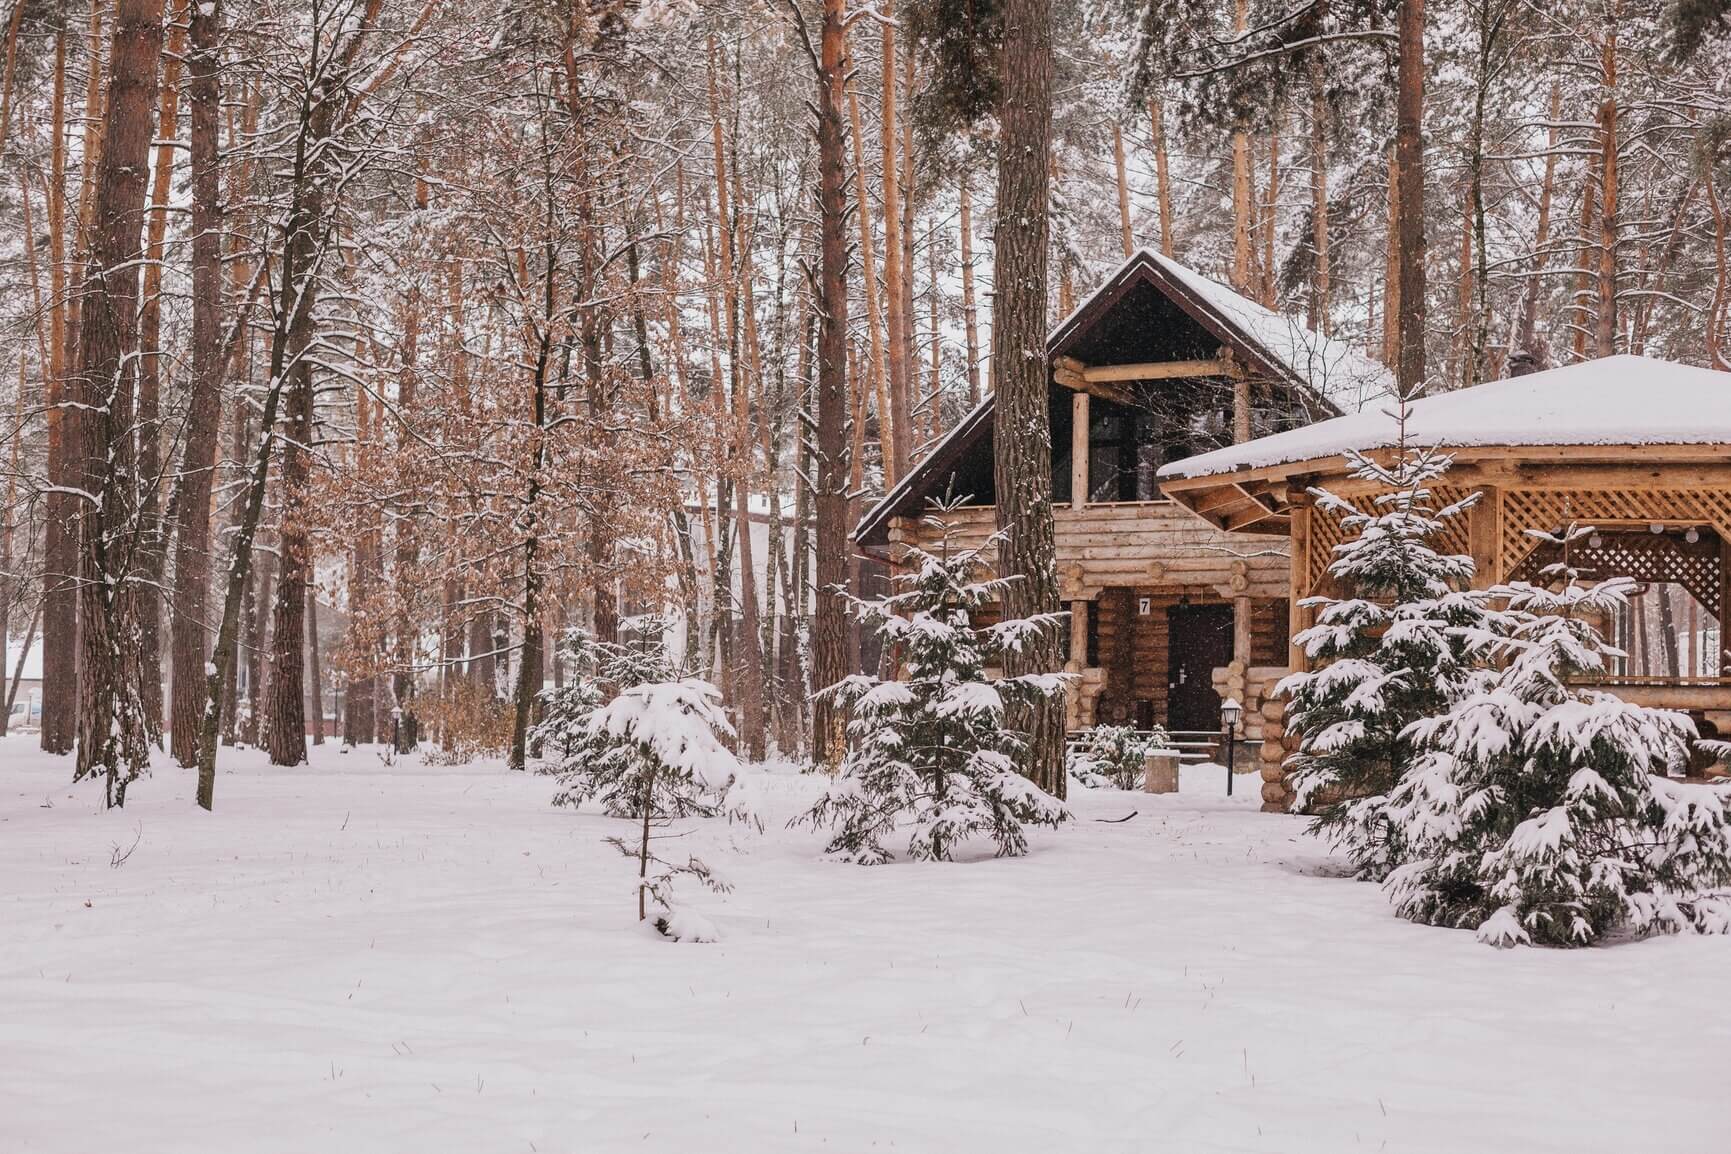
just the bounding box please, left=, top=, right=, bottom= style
left=855, top=249, right=1390, bottom=740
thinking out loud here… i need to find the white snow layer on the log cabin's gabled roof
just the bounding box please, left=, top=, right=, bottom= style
left=1052, top=247, right=1395, bottom=414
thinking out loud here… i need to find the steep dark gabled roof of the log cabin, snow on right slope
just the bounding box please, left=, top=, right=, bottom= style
left=853, top=249, right=1390, bottom=547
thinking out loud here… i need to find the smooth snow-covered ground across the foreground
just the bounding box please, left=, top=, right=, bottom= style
left=0, top=735, right=1731, bottom=1154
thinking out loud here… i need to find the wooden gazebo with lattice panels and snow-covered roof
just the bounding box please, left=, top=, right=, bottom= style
left=1160, top=356, right=1731, bottom=808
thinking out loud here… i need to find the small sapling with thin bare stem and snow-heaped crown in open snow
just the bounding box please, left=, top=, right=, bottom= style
left=537, top=630, right=741, bottom=941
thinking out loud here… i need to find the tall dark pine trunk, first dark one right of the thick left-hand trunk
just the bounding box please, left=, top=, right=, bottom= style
left=170, top=3, right=223, bottom=766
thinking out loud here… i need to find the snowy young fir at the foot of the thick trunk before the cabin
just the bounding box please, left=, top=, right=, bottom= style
left=795, top=509, right=1066, bottom=865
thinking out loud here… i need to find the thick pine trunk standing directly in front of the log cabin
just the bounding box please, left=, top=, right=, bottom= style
left=992, top=0, right=1065, bottom=798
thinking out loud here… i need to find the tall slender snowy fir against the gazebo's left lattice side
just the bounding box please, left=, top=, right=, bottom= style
left=1277, top=429, right=1489, bottom=881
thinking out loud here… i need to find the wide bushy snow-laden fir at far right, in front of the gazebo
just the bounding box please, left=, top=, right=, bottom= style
left=1387, top=529, right=1731, bottom=946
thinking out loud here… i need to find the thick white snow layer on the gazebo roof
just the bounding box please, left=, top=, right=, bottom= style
left=1160, top=355, right=1731, bottom=478
